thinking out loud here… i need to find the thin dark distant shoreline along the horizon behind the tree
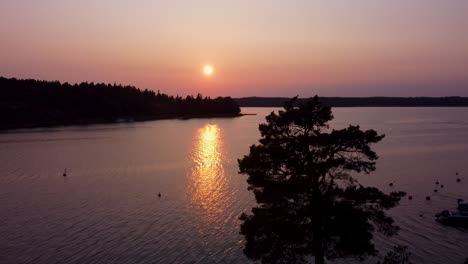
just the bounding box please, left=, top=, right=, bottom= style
left=234, top=96, right=468, bottom=107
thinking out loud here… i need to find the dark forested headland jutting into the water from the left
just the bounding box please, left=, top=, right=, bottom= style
left=0, top=77, right=240, bottom=129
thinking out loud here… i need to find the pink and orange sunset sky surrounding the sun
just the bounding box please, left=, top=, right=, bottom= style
left=0, top=0, right=468, bottom=97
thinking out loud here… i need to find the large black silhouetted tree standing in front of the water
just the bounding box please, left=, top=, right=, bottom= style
left=238, top=96, right=404, bottom=264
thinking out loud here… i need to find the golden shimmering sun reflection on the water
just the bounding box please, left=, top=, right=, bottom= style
left=188, top=124, right=226, bottom=219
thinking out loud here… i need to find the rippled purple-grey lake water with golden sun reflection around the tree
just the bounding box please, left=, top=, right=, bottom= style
left=0, top=108, right=468, bottom=263
